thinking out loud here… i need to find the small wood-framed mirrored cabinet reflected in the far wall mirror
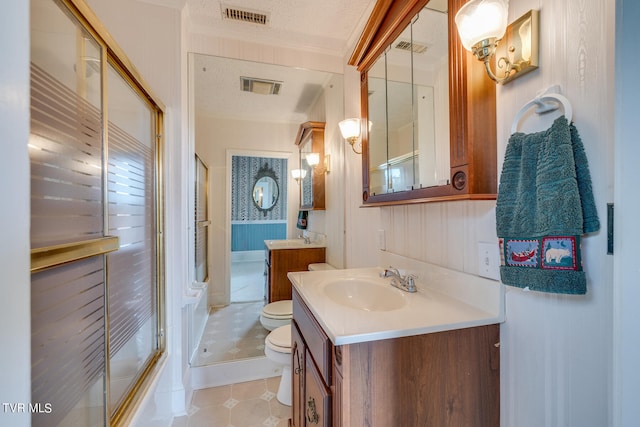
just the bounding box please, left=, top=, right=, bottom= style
left=295, top=122, right=325, bottom=210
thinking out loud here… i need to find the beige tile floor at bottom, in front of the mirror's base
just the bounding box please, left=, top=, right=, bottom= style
left=172, top=377, right=291, bottom=427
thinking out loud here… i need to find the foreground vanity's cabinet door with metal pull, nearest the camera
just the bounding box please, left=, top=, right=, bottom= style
left=303, top=352, right=331, bottom=427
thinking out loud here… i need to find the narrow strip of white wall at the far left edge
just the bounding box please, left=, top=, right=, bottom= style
left=0, top=2, right=30, bottom=427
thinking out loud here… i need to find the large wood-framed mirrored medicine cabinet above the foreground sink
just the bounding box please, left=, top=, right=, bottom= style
left=349, top=0, right=497, bottom=206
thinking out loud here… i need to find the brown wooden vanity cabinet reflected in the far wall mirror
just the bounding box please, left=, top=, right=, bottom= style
left=265, top=247, right=326, bottom=303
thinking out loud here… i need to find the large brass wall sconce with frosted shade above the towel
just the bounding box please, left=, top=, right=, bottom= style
left=456, top=0, right=539, bottom=84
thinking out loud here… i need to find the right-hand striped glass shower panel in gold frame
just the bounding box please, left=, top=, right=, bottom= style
left=107, top=65, right=159, bottom=413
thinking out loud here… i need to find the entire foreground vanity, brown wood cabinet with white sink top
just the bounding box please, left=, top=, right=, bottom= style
left=289, top=269, right=504, bottom=427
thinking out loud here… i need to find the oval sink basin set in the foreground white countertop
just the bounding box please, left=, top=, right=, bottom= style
left=324, top=278, right=406, bottom=311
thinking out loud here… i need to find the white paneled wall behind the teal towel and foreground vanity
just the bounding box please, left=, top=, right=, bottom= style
left=345, top=0, right=615, bottom=427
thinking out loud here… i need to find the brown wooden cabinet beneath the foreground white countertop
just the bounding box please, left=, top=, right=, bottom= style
left=292, top=289, right=500, bottom=427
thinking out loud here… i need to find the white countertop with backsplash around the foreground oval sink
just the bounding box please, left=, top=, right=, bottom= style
left=288, top=264, right=504, bottom=345
